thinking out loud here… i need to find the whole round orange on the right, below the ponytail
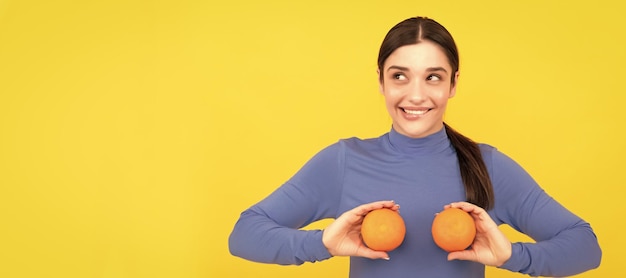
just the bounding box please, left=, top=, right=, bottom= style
left=432, top=208, right=476, bottom=252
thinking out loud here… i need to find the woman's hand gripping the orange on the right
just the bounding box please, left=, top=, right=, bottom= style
left=445, top=202, right=511, bottom=266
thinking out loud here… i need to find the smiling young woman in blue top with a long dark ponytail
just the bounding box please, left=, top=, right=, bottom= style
left=229, top=17, right=602, bottom=277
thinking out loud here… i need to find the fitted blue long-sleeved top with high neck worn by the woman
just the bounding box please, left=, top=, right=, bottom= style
left=229, top=128, right=602, bottom=278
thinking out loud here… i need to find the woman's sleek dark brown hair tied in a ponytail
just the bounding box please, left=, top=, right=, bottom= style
left=378, top=17, right=494, bottom=210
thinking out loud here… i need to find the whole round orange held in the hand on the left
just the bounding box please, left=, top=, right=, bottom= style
left=361, top=208, right=406, bottom=251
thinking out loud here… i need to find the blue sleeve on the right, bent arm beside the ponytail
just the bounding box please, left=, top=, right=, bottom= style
left=488, top=149, right=602, bottom=277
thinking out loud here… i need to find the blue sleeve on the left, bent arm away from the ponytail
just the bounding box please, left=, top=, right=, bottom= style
left=229, top=144, right=343, bottom=265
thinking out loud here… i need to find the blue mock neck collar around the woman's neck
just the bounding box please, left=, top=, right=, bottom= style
left=389, top=127, right=452, bottom=154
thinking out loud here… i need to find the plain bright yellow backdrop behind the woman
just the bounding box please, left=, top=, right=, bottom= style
left=0, top=0, right=626, bottom=277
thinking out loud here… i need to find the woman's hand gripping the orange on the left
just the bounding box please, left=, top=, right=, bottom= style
left=322, top=201, right=400, bottom=260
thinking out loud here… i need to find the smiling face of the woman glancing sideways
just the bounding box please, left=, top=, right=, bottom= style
left=380, top=41, right=458, bottom=138
